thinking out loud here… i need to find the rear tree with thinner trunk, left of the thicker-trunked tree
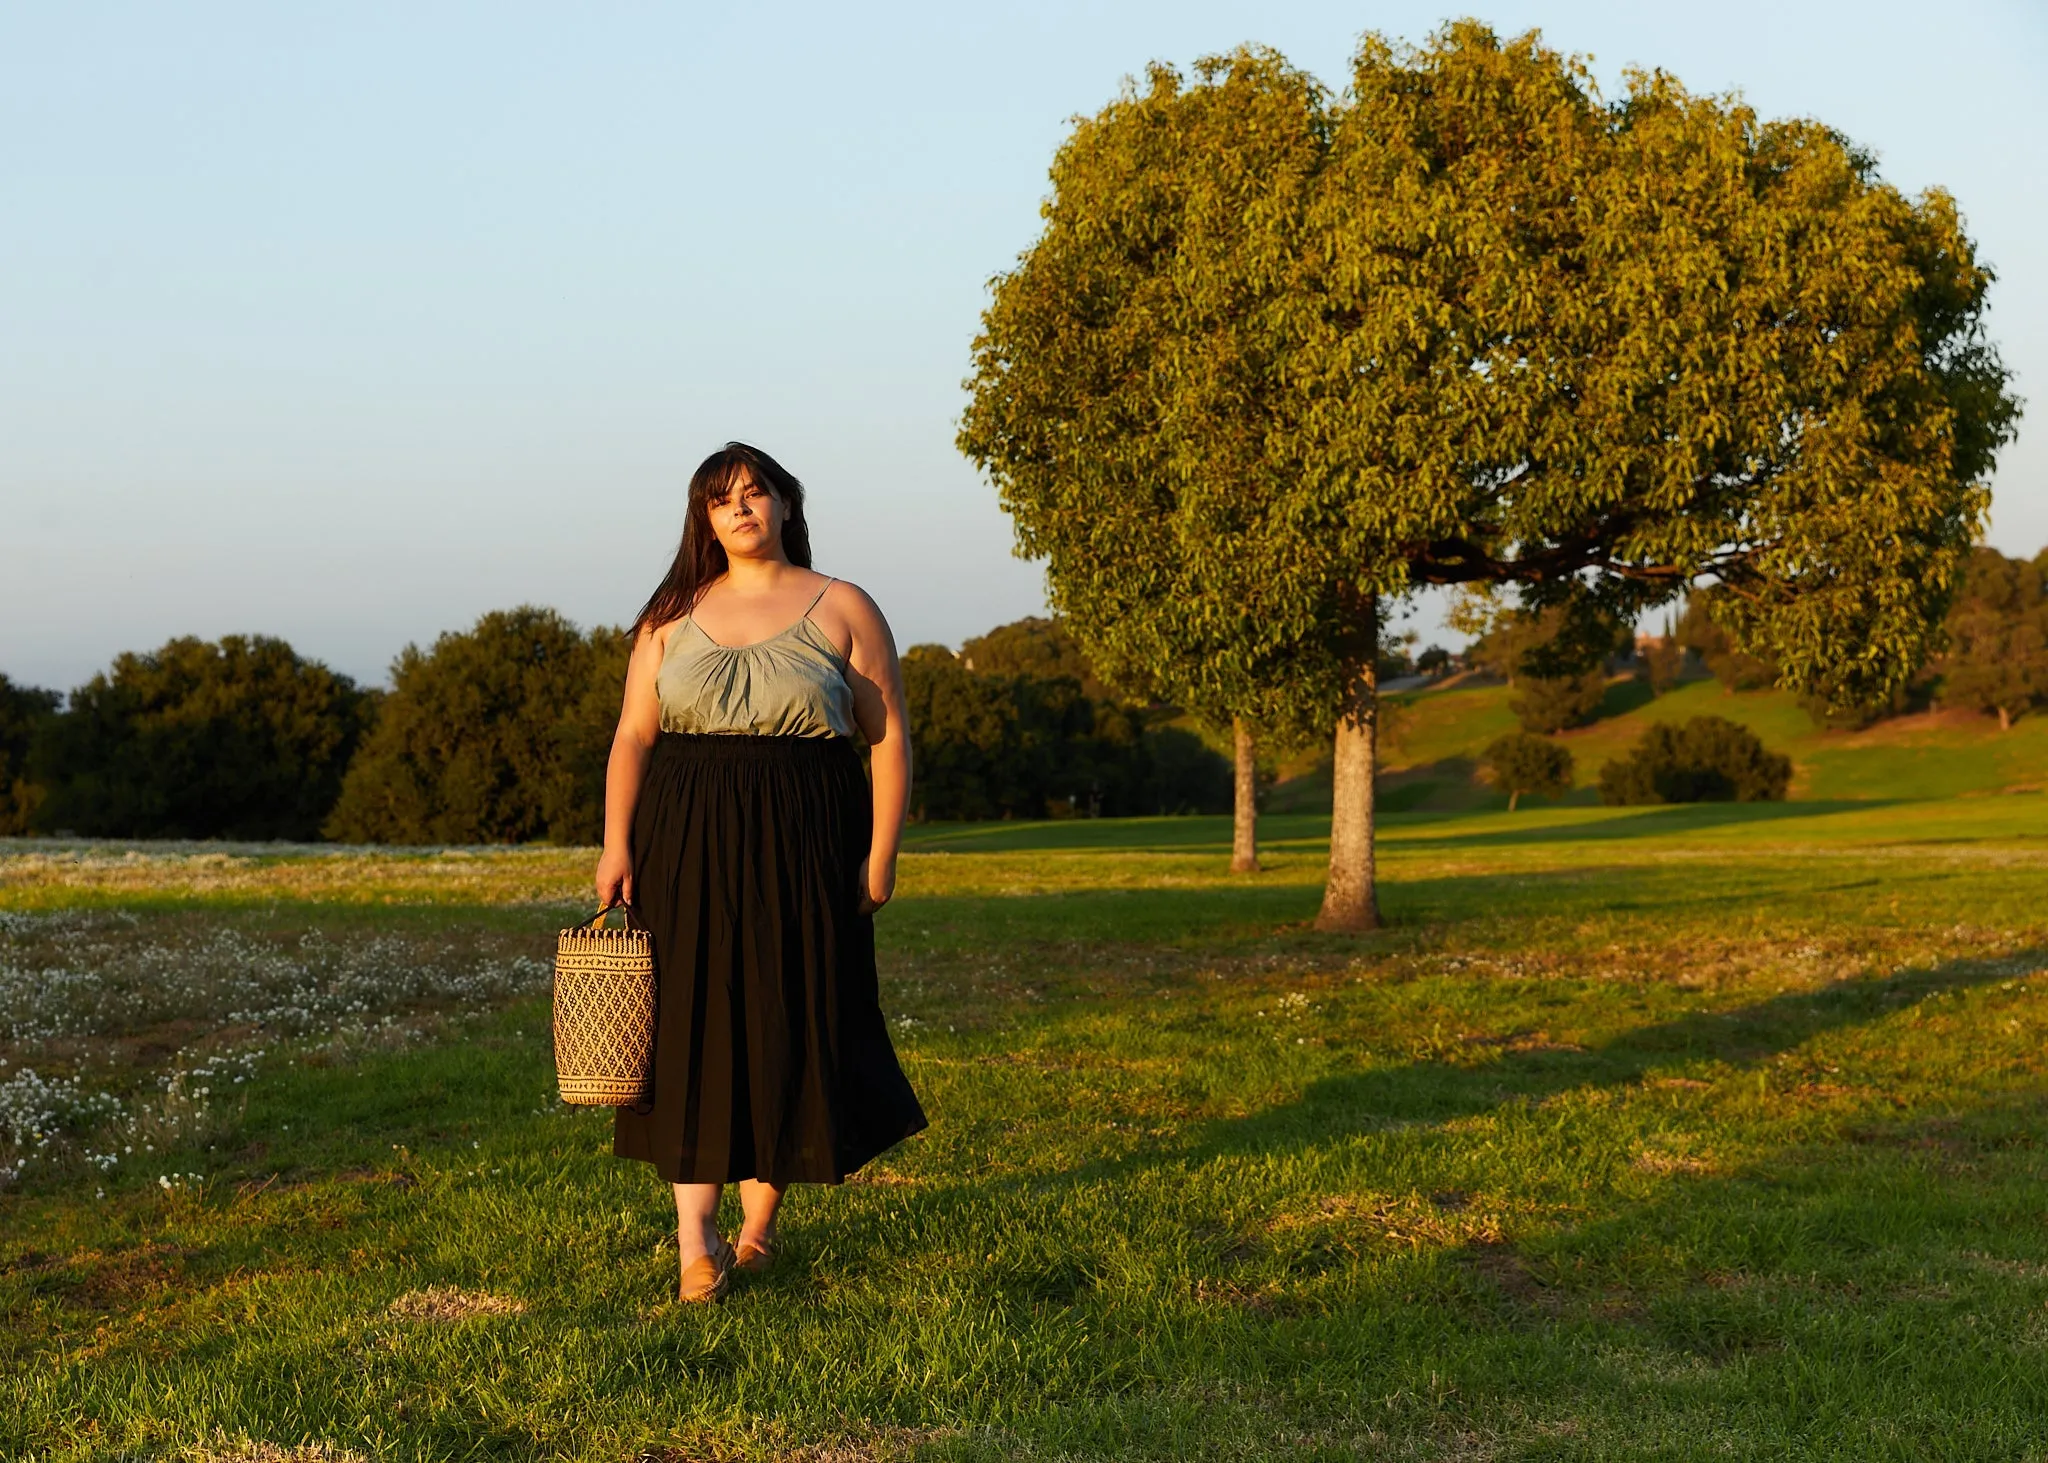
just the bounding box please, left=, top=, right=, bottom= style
left=961, top=51, right=1333, bottom=869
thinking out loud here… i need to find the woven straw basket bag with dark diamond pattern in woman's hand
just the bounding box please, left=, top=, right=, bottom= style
left=555, top=904, right=655, bottom=1106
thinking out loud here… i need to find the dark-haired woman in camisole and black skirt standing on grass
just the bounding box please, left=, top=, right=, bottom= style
left=596, top=443, right=924, bottom=1301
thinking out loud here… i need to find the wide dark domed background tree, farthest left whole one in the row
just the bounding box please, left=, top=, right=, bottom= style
left=29, top=635, right=375, bottom=838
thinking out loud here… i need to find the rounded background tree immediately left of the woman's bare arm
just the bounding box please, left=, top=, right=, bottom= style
left=326, top=604, right=627, bottom=844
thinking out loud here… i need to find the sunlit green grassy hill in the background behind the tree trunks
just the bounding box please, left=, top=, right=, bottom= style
left=1272, top=680, right=2048, bottom=811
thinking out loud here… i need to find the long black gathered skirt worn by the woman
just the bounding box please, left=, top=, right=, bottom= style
left=612, top=732, right=926, bottom=1184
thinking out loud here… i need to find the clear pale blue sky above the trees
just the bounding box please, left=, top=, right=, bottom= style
left=0, top=0, right=2048, bottom=688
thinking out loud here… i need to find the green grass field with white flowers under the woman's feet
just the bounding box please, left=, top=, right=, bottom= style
left=0, top=790, right=2048, bottom=1463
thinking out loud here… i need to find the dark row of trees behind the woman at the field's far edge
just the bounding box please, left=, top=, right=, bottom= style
left=0, top=607, right=1231, bottom=844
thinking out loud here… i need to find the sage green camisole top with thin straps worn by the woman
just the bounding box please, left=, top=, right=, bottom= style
left=653, top=580, right=854, bottom=738
